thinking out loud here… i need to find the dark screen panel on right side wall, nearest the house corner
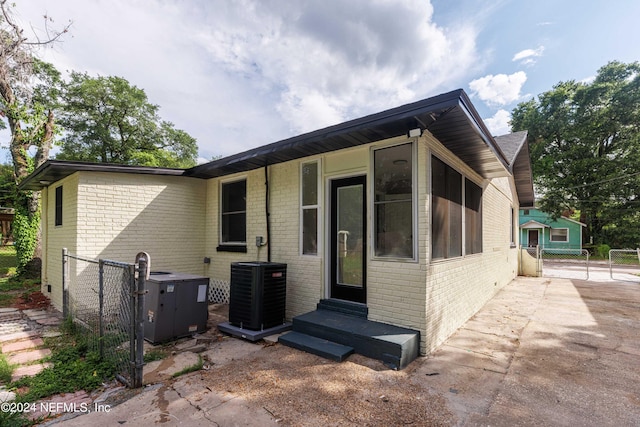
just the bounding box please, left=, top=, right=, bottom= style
left=431, top=157, right=462, bottom=259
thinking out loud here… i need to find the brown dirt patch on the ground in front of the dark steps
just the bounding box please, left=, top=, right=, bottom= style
left=201, top=345, right=455, bottom=426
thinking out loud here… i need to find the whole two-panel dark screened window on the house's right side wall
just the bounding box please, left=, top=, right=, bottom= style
left=431, top=157, right=482, bottom=259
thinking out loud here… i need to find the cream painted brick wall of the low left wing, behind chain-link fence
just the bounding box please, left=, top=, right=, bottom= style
left=43, top=172, right=206, bottom=308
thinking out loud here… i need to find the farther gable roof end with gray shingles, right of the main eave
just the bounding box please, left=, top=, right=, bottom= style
left=495, top=130, right=535, bottom=208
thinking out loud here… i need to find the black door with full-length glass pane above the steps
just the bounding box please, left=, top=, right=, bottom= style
left=329, top=176, right=367, bottom=303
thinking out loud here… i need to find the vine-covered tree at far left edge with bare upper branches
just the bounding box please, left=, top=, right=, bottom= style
left=0, top=0, right=71, bottom=272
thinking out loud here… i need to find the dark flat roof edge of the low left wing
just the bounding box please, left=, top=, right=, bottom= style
left=18, top=160, right=185, bottom=190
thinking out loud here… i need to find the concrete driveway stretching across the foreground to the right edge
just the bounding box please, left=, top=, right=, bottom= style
left=51, top=277, right=640, bottom=427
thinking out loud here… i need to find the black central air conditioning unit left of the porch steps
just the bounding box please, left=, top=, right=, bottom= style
left=229, top=261, right=287, bottom=331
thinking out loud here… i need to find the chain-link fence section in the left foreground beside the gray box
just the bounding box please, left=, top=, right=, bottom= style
left=62, top=249, right=146, bottom=387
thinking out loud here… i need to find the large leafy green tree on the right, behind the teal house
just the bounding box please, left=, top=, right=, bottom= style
left=511, top=62, right=640, bottom=247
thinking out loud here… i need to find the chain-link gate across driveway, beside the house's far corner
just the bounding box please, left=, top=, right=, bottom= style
left=540, top=248, right=589, bottom=280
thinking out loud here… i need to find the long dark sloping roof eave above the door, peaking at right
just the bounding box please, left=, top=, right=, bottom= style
left=186, top=89, right=508, bottom=178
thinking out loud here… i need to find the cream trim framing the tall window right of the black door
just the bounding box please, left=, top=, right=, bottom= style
left=369, top=138, right=420, bottom=262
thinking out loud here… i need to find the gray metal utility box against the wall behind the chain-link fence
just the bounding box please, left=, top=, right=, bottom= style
left=144, top=271, right=209, bottom=344
